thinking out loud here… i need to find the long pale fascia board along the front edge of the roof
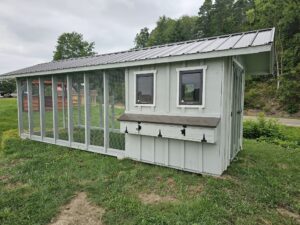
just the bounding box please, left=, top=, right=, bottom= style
left=4, top=43, right=272, bottom=79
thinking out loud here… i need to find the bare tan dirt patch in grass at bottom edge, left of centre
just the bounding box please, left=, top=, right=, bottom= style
left=49, top=192, right=105, bottom=225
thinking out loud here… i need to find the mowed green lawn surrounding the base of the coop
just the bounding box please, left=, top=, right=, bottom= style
left=0, top=99, right=300, bottom=225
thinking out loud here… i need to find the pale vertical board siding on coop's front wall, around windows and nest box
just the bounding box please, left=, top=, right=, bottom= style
left=125, top=59, right=228, bottom=174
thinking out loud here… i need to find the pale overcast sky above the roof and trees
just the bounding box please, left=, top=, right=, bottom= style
left=0, top=0, right=204, bottom=74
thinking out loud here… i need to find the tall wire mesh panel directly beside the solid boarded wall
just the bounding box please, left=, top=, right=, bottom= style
left=107, top=70, right=125, bottom=150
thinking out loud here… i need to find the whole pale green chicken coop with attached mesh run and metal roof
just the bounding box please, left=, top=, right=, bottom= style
left=1, top=28, right=275, bottom=175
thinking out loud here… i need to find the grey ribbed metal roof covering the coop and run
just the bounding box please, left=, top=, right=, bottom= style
left=2, top=28, right=275, bottom=76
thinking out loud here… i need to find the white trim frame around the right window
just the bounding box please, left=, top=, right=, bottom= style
left=176, top=66, right=207, bottom=109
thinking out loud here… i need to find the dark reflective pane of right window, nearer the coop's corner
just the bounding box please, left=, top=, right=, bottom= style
left=179, top=70, right=203, bottom=105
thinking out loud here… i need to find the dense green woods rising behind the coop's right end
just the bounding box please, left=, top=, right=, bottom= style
left=134, top=0, right=300, bottom=113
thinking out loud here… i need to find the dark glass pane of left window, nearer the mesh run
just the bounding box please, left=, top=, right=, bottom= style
left=136, top=74, right=153, bottom=104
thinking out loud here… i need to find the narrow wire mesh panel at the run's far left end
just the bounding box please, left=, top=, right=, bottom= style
left=20, top=79, right=29, bottom=134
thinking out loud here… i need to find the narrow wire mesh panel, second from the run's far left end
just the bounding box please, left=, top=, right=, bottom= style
left=31, top=79, right=41, bottom=136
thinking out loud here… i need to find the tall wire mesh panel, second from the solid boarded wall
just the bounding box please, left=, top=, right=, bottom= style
left=88, top=72, right=104, bottom=146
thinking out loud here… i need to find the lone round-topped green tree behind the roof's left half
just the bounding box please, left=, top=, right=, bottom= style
left=53, top=32, right=96, bottom=60
